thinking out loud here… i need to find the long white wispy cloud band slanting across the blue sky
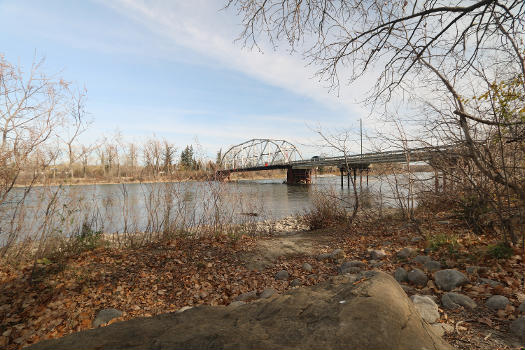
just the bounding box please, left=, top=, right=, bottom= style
left=99, top=0, right=363, bottom=116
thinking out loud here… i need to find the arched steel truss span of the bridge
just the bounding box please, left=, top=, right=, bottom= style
left=221, top=139, right=303, bottom=169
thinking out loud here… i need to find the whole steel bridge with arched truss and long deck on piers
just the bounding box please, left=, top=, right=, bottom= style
left=216, top=139, right=456, bottom=186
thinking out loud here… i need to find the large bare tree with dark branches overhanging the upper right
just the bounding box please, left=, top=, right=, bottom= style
left=227, top=0, right=525, bottom=241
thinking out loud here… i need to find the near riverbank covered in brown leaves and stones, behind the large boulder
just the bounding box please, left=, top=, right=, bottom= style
left=0, top=215, right=525, bottom=349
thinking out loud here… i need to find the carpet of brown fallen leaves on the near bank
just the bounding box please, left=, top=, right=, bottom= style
left=0, top=216, right=525, bottom=350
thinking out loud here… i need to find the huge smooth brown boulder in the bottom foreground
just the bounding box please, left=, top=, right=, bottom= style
left=29, top=271, right=452, bottom=350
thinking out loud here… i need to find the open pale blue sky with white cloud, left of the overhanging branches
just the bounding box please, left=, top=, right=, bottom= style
left=0, top=0, right=376, bottom=158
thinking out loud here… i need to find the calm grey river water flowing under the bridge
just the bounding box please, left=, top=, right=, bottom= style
left=0, top=173, right=433, bottom=236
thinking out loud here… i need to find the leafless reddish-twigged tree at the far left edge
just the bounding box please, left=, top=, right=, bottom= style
left=0, top=55, right=67, bottom=204
